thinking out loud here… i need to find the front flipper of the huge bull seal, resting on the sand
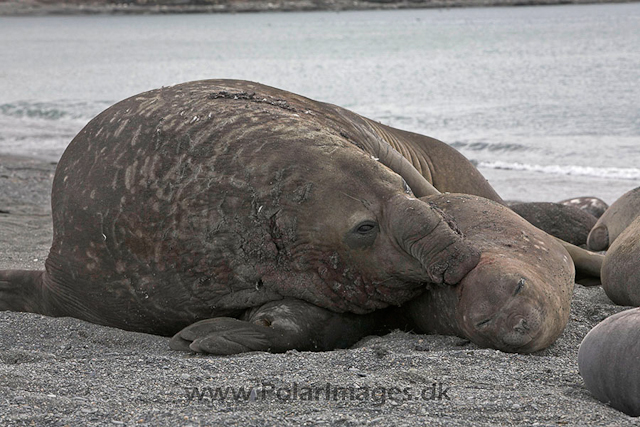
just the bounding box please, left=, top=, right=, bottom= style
left=169, top=299, right=375, bottom=355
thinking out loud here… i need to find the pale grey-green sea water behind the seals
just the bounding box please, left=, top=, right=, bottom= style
left=0, top=3, right=640, bottom=203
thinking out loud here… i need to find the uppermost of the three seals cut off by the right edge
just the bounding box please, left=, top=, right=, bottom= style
left=587, top=187, right=640, bottom=251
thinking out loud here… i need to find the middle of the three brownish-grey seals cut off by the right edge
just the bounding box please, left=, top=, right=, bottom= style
left=601, top=216, right=640, bottom=307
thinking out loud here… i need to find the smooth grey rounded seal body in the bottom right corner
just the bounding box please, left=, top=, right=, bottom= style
left=578, top=308, right=640, bottom=417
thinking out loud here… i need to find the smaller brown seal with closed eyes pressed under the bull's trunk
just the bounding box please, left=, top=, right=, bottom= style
left=405, top=194, right=574, bottom=353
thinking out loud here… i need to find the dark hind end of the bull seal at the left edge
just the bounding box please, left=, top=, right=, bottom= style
left=0, top=270, right=46, bottom=314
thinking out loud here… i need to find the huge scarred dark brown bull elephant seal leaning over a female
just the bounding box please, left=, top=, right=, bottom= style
left=0, top=80, right=480, bottom=354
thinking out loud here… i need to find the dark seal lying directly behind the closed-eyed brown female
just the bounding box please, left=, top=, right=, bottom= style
left=510, top=202, right=597, bottom=246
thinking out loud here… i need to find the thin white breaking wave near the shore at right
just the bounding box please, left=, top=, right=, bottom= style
left=478, top=161, right=640, bottom=179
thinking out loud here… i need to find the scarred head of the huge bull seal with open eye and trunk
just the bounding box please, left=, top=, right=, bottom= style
left=250, top=121, right=480, bottom=313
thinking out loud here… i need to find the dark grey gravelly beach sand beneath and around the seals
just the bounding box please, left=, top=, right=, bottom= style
left=0, top=156, right=640, bottom=426
